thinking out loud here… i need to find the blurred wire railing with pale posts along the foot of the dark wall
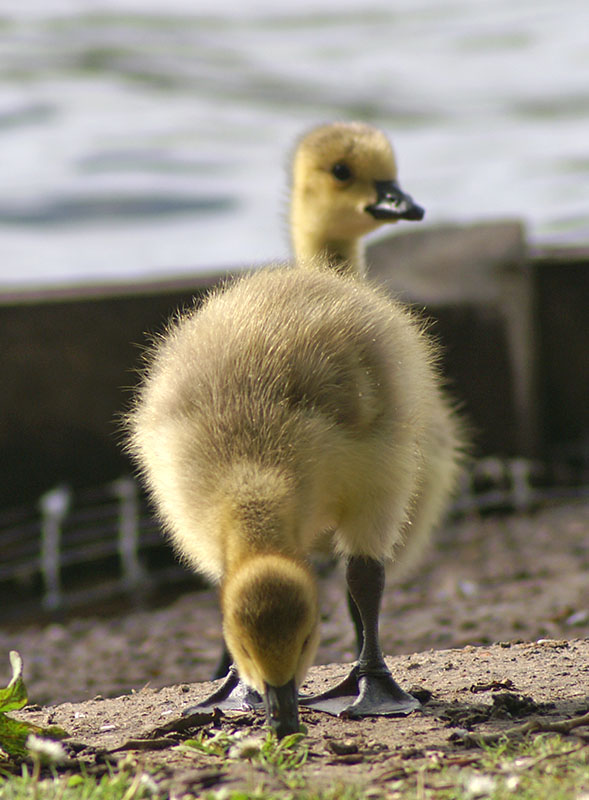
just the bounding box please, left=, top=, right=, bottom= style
left=0, top=458, right=589, bottom=623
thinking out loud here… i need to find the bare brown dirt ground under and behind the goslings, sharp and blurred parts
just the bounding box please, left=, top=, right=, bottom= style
left=0, top=502, right=589, bottom=796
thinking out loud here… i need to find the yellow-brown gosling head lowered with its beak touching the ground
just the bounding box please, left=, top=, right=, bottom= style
left=222, top=555, right=318, bottom=737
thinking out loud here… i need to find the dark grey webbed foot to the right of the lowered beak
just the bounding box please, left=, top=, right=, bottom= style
left=299, top=665, right=421, bottom=719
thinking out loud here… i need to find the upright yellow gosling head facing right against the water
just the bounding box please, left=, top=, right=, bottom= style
left=291, top=122, right=425, bottom=266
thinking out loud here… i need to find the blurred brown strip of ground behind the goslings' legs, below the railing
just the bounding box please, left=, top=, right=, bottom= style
left=0, top=502, right=589, bottom=704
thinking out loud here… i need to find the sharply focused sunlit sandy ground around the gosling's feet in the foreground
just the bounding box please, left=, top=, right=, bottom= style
left=9, top=639, right=589, bottom=798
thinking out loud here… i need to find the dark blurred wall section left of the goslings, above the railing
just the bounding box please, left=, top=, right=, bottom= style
left=0, top=276, right=214, bottom=507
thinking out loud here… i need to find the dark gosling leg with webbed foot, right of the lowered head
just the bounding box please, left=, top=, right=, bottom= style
left=300, top=556, right=420, bottom=719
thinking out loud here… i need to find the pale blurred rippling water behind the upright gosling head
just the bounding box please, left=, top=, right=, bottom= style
left=0, top=0, right=589, bottom=287
